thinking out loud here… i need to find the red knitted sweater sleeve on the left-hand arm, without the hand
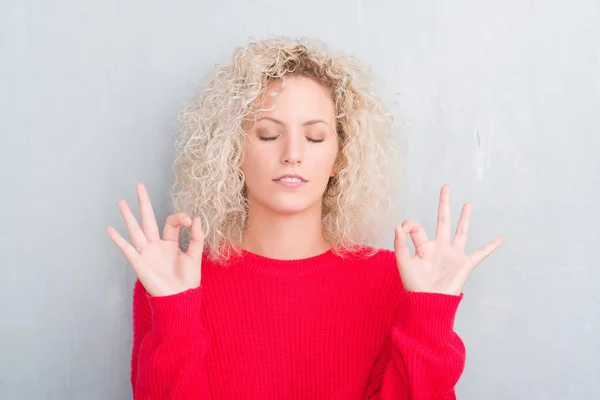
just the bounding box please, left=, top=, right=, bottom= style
left=131, top=280, right=210, bottom=400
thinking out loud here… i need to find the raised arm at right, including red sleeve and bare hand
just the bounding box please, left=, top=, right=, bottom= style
left=366, top=184, right=504, bottom=400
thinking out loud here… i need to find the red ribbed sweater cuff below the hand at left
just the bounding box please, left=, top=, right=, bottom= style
left=147, top=286, right=202, bottom=337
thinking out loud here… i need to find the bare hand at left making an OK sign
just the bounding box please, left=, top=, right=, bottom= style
left=106, top=183, right=204, bottom=296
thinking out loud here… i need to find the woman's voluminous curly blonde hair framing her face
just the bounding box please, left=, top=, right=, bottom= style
left=171, top=37, right=396, bottom=262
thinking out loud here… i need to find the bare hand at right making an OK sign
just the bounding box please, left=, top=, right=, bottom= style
left=394, top=184, right=504, bottom=295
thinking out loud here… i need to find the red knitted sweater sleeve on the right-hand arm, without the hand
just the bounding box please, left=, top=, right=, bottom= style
left=365, top=291, right=466, bottom=400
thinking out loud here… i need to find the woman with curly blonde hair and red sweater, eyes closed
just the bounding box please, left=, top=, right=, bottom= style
left=107, top=38, right=503, bottom=399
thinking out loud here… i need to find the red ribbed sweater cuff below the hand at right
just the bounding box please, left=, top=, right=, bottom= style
left=400, top=292, right=464, bottom=337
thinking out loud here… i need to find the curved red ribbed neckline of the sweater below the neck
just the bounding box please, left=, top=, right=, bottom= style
left=234, top=249, right=339, bottom=277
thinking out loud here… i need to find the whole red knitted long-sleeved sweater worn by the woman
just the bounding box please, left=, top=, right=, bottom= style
left=131, top=245, right=465, bottom=400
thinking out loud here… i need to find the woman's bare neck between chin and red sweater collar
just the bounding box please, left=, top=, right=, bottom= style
left=242, top=205, right=331, bottom=260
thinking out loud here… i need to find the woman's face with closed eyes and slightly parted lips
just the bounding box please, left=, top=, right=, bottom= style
left=242, top=76, right=338, bottom=214
